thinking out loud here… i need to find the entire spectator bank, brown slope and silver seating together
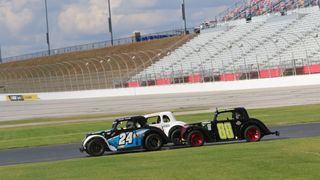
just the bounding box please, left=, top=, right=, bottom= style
left=0, top=0, right=320, bottom=93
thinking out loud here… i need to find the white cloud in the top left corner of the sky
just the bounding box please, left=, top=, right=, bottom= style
left=0, top=0, right=37, bottom=33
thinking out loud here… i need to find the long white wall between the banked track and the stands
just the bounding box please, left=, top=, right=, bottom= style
left=0, top=74, right=320, bottom=101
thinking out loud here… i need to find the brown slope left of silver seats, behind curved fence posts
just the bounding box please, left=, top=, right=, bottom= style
left=0, top=35, right=194, bottom=93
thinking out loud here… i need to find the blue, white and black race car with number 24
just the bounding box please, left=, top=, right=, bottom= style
left=80, top=116, right=169, bottom=156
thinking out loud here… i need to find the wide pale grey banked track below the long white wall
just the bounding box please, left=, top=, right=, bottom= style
left=0, top=85, right=320, bottom=121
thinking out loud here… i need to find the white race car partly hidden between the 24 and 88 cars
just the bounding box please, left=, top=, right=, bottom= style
left=144, top=112, right=187, bottom=145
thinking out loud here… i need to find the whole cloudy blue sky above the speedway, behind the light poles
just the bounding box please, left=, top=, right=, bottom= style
left=0, top=0, right=239, bottom=57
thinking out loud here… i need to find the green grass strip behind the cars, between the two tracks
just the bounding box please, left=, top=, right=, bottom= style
left=0, top=105, right=320, bottom=149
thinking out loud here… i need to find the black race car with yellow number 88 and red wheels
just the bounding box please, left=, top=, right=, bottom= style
left=180, top=107, right=279, bottom=146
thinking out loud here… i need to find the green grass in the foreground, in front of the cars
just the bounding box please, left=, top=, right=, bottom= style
left=0, top=137, right=320, bottom=180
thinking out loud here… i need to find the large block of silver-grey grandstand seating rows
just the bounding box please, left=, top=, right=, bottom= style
left=131, top=6, right=320, bottom=81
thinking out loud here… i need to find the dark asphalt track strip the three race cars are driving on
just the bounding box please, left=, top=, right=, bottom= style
left=0, top=123, right=320, bottom=166
